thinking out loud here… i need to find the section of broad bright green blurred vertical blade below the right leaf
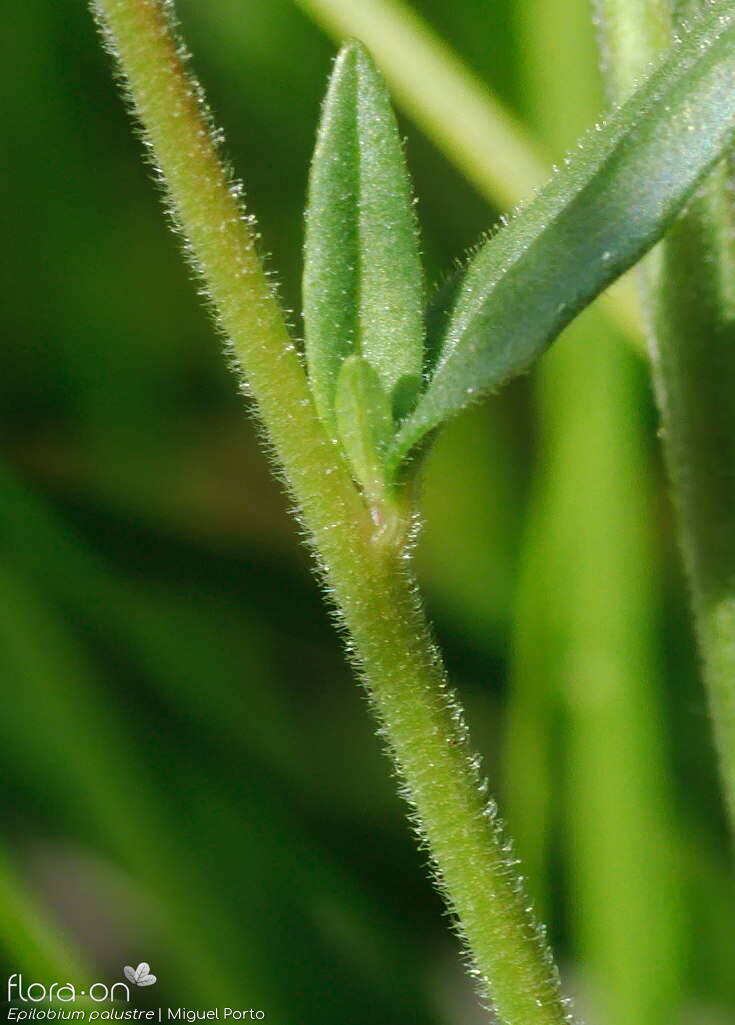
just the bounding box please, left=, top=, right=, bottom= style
left=522, top=312, right=685, bottom=1025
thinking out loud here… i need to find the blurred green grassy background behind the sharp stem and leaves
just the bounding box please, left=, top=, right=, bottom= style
left=0, top=0, right=735, bottom=1025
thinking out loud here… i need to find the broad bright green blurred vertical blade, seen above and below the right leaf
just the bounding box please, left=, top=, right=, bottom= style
left=505, top=0, right=691, bottom=1025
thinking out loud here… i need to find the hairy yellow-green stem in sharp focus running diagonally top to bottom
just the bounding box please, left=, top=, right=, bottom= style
left=93, top=0, right=568, bottom=1025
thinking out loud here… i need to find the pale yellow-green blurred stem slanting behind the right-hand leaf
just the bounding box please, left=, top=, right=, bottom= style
left=296, top=0, right=643, bottom=340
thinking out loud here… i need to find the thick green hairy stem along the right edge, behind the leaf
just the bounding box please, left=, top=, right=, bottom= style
left=600, top=0, right=735, bottom=832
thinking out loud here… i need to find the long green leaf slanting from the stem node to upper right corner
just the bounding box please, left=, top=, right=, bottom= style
left=389, top=0, right=735, bottom=473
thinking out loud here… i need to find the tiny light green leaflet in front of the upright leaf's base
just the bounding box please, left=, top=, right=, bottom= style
left=334, top=356, right=393, bottom=504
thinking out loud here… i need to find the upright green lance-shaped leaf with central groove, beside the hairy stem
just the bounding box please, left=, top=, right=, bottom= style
left=303, top=42, right=423, bottom=428
